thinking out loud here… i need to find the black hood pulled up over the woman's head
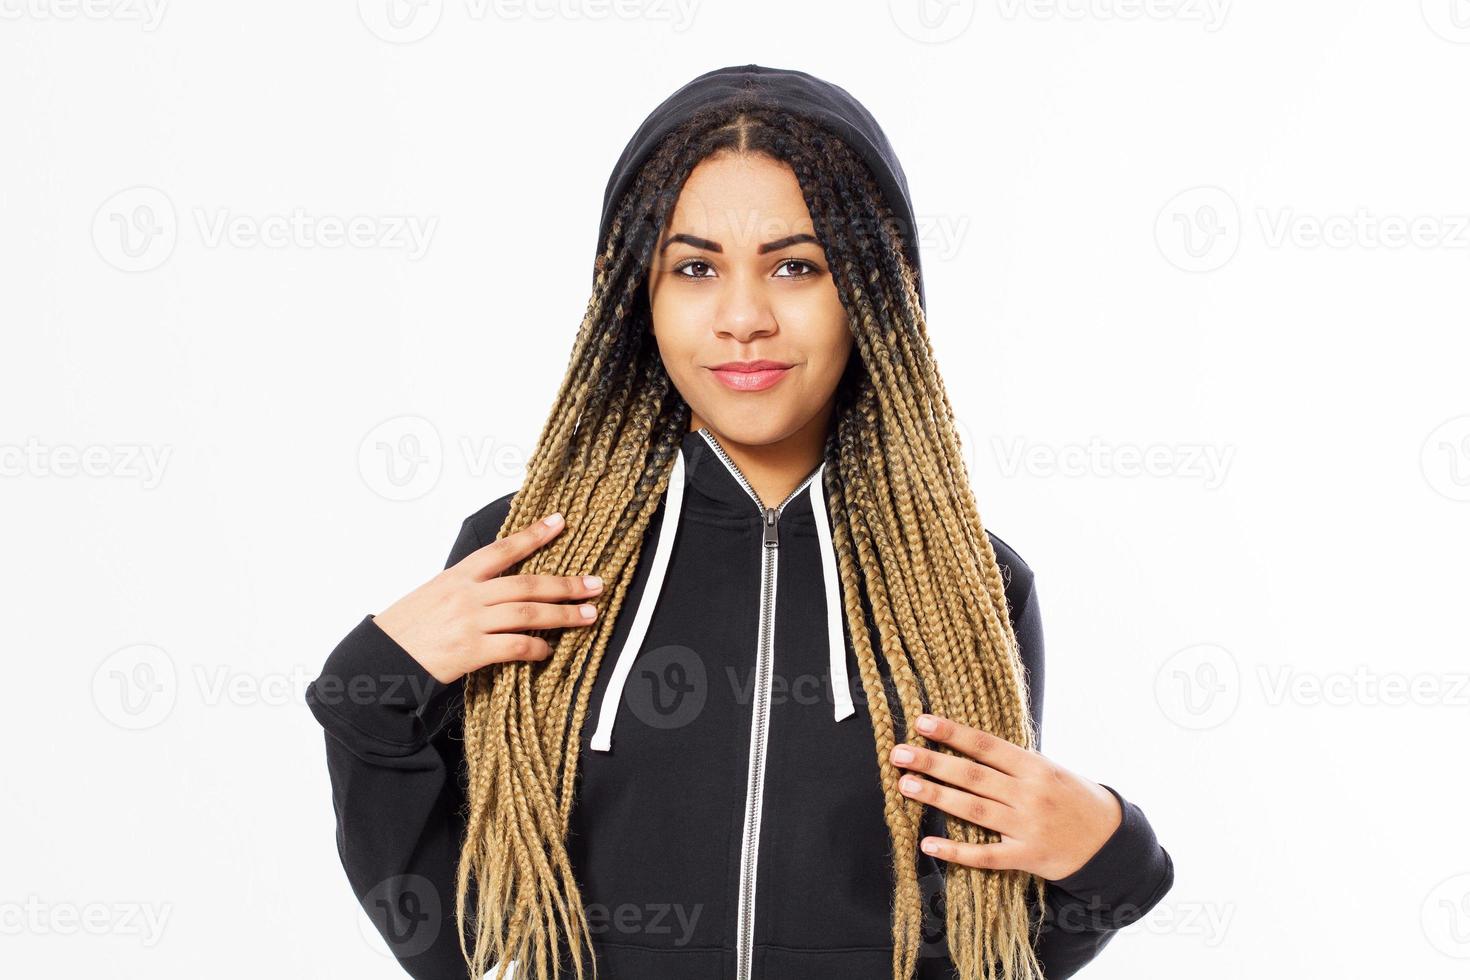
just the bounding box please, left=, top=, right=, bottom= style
left=597, top=65, right=925, bottom=307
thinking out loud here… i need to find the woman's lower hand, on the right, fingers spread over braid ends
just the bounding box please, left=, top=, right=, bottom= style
left=889, top=714, right=1123, bottom=882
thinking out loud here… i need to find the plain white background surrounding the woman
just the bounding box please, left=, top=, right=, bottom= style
left=0, top=0, right=1470, bottom=980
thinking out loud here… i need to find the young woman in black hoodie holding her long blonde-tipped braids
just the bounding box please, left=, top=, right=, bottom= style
left=307, top=65, right=1173, bottom=980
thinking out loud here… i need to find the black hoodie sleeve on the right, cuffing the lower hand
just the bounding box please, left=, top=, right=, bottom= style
left=1007, top=548, right=1175, bottom=980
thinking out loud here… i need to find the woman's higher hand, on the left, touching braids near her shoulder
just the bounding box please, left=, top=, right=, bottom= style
left=373, top=514, right=603, bottom=685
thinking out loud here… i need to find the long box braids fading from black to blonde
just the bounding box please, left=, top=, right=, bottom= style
left=456, top=98, right=1042, bottom=980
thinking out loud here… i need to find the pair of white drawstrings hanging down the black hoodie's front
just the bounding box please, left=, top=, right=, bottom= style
left=591, top=453, right=854, bottom=752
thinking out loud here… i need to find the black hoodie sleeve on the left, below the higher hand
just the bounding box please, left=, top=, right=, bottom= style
left=306, top=497, right=510, bottom=980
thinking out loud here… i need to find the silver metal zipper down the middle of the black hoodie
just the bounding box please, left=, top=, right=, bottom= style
left=700, top=429, right=822, bottom=980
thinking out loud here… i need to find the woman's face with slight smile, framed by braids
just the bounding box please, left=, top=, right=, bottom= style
left=648, top=153, right=853, bottom=445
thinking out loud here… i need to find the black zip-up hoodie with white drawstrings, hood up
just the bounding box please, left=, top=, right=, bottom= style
left=306, top=65, right=1173, bottom=980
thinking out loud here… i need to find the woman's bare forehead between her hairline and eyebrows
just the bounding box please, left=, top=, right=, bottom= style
left=667, top=153, right=814, bottom=251
